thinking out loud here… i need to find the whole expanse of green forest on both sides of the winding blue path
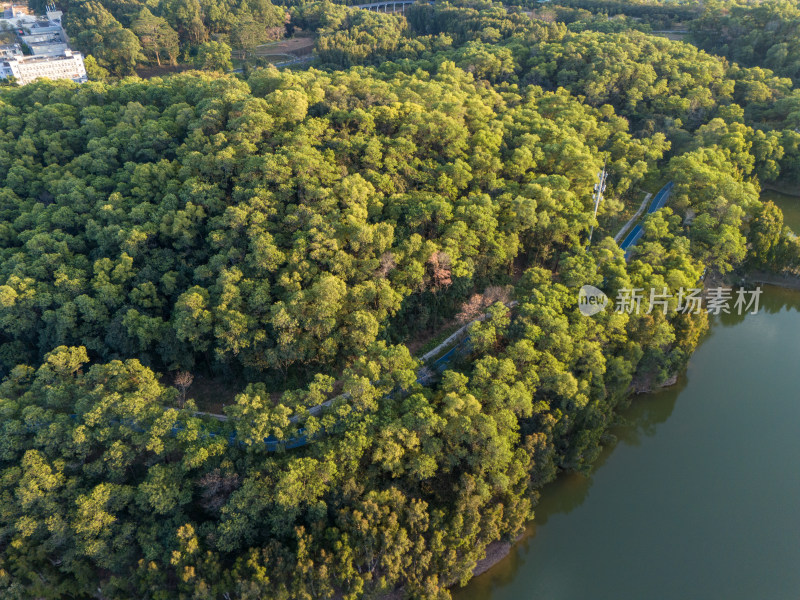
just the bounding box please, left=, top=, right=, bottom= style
left=0, top=0, right=800, bottom=600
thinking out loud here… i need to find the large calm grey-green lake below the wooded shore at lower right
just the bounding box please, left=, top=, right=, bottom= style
left=454, top=284, right=800, bottom=600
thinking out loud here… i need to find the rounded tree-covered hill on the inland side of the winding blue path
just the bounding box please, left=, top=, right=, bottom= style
left=0, top=62, right=667, bottom=380
